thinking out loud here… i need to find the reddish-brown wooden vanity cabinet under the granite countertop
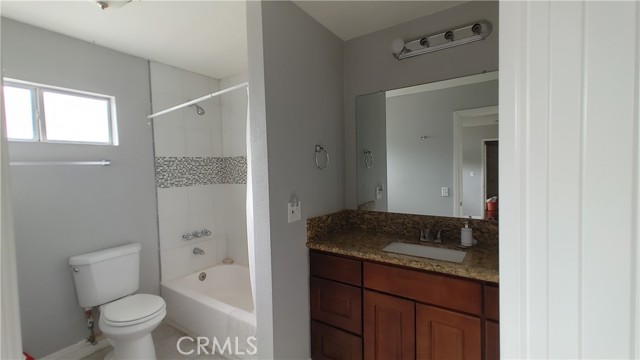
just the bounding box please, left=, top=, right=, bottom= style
left=310, top=251, right=500, bottom=360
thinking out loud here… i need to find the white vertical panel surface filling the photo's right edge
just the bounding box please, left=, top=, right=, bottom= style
left=500, top=1, right=640, bottom=359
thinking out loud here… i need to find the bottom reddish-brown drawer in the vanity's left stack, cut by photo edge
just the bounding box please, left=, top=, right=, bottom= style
left=311, top=321, right=362, bottom=360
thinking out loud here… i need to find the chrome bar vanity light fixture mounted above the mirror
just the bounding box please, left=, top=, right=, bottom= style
left=391, top=20, right=493, bottom=60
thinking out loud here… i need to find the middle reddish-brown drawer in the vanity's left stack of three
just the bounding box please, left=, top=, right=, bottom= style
left=311, top=276, right=362, bottom=335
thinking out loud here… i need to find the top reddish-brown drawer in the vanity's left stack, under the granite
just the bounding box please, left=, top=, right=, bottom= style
left=309, top=252, right=362, bottom=286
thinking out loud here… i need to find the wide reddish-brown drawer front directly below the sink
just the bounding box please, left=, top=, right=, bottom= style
left=364, top=262, right=482, bottom=315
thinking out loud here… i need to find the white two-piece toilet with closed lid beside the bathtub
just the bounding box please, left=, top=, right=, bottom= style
left=69, top=243, right=167, bottom=360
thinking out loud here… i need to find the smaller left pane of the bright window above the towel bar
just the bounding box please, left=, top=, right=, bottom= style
left=4, top=86, right=35, bottom=140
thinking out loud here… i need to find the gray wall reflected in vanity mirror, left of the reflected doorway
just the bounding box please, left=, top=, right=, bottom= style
left=387, top=80, right=498, bottom=216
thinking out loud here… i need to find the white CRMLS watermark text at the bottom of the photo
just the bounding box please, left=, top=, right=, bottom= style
left=176, top=336, right=258, bottom=355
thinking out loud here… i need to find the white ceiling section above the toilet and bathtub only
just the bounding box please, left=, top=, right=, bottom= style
left=0, top=0, right=248, bottom=79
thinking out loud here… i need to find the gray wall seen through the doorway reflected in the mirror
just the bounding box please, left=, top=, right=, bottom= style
left=462, top=125, right=498, bottom=217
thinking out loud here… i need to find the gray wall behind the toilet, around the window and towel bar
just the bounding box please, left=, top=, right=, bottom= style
left=2, top=18, right=159, bottom=357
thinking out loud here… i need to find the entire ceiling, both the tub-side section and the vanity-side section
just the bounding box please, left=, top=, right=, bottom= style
left=0, top=0, right=462, bottom=79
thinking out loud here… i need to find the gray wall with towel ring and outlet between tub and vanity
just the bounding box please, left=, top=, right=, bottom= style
left=258, top=2, right=344, bottom=359
